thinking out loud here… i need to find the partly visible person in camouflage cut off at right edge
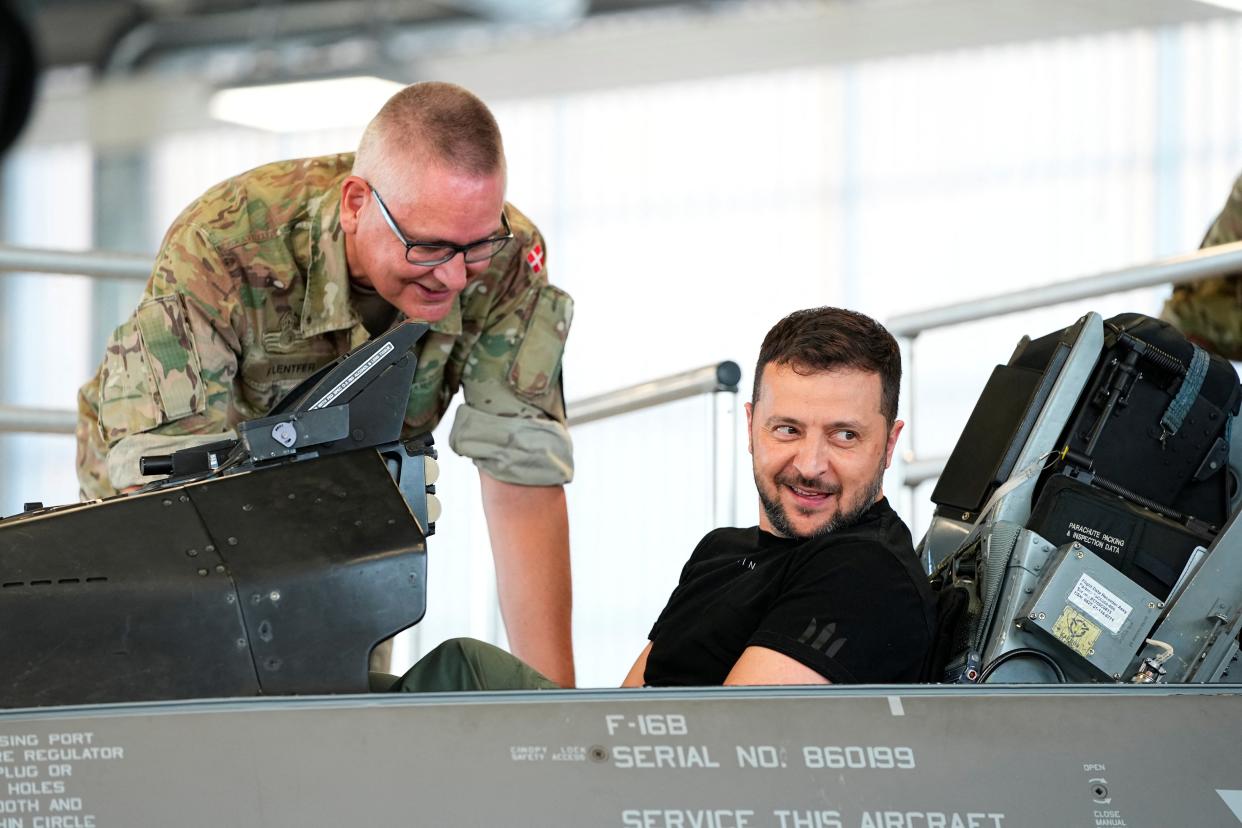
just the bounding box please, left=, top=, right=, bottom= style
left=1161, top=176, right=1242, bottom=361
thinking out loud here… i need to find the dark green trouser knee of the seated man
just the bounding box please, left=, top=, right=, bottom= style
left=373, top=638, right=560, bottom=693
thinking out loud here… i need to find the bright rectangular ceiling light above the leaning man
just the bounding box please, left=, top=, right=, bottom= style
left=209, top=76, right=402, bottom=133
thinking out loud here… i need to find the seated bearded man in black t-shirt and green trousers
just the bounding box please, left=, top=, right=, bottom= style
left=394, top=308, right=935, bottom=691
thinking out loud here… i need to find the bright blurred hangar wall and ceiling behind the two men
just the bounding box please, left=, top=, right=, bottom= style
left=0, top=0, right=1242, bottom=686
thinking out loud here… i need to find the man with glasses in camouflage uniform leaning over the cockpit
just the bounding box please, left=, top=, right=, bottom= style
left=77, top=83, right=574, bottom=686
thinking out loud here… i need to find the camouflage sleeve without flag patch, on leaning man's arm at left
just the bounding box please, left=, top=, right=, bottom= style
left=77, top=221, right=240, bottom=498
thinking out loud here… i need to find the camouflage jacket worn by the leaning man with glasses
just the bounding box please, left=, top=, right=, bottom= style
left=77, top=154, right=573, bottom=498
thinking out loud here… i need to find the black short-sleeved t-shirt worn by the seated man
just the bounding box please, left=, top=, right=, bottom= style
left=645, top=498, right=935, bottom=686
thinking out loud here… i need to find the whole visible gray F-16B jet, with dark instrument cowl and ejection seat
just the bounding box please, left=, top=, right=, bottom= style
left=0, top=313, right=1242, bottom=828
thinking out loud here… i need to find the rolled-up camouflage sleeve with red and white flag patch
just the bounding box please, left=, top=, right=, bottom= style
left=448, top=223, right=574, bottom=485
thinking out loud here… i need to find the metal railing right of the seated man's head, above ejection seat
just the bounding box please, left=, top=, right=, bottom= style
left=887, top=242, right=1242, bottom=514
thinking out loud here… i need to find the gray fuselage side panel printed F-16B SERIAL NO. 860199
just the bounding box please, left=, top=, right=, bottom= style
left=0, top=686, right=1242, bottom=828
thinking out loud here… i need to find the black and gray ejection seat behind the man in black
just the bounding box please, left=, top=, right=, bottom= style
left=918, top=313, right=1242, bottom=683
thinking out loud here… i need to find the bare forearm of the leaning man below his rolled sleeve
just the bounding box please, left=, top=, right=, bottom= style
left=478, top=472, right=574, bottom=688
